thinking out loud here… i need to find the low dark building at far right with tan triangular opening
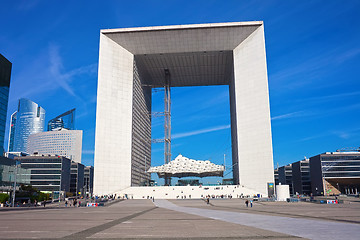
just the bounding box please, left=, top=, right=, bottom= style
left=310, top=151, right=360, bottom=195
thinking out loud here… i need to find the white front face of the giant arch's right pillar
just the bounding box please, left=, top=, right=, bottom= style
left=230, top=26, right=274, bottom=194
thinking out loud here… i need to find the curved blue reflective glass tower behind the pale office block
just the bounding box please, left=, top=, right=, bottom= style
left=9, top=98, right=45, bottom=152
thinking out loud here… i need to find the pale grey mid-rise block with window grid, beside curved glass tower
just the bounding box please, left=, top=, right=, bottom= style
left=26, top=128, right=82, bottom=163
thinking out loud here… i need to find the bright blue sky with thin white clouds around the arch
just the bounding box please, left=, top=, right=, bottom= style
left=0, top=0, right=360, bottom=184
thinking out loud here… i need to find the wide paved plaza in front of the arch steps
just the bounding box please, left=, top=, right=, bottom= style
left=0, top=199, right=360, bottom=239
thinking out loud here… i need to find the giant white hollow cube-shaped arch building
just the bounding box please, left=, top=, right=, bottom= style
left=94, top=22, right=274, bottom=196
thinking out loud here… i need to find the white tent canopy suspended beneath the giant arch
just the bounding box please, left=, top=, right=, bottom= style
left=147, top=154, right=225, bottom=178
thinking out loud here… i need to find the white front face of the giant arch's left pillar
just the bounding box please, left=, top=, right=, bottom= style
left=94, top=34, right=134, bottom=195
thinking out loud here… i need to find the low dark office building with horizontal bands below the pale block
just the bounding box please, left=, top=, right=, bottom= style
left=15, top=155, right=71, bottom=192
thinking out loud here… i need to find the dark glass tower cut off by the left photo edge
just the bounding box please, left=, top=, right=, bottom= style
left=0, top=54, right=12, bottom=152
